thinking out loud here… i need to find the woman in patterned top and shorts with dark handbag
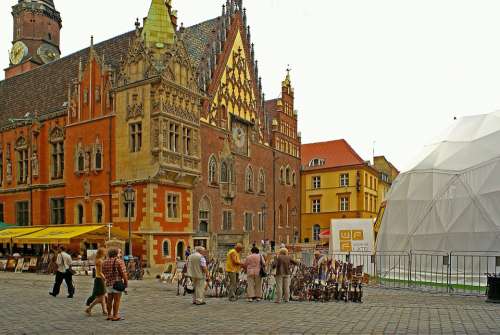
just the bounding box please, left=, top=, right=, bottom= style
left=102, top=249, right=128, bottom=321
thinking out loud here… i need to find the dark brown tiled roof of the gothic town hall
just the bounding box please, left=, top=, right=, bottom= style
left=0, top=18, right=218, bottom=127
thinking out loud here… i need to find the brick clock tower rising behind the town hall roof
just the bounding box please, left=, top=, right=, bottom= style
left=5, top=0, right=62, bottom=79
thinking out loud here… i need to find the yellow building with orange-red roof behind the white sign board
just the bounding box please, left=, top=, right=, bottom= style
left=301, top=140, right=380, bottom=243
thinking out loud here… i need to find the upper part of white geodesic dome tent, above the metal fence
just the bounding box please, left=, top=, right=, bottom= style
left=377, top=112, right=500, bottom=252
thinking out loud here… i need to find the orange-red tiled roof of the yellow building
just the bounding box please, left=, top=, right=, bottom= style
left=301, top=139, right=364, bottom=170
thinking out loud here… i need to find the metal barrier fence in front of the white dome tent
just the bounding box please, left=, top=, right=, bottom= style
left=318, top=251, right=500, bottom=295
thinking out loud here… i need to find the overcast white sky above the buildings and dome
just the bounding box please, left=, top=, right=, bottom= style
left=0, top=0, right=500, bottom=168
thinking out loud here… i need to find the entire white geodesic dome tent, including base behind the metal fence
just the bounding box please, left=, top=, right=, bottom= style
left=376, top=112, right=500, bottom=292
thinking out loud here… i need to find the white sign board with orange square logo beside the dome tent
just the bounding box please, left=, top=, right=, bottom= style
left=330, top=219, right=375, bottom=253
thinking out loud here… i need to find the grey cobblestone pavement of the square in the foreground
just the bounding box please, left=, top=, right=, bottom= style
left=0, top=273, right=500, bottom=334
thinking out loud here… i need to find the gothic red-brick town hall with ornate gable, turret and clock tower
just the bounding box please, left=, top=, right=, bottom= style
left=0, top=0, right=300, bottom=267
